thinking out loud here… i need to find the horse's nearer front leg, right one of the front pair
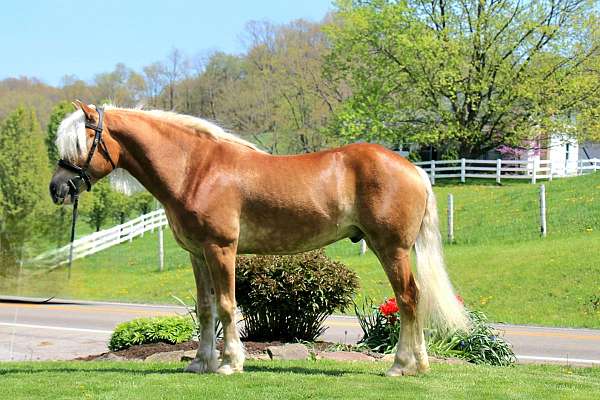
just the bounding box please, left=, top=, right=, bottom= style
left=204, top=243, right=245, bottom=375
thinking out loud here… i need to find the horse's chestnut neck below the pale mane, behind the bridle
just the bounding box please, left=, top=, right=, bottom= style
left=110, top=112, right=213, bottom=204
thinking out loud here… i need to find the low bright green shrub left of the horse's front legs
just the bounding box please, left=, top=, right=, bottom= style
left=108, top=316, right=194, bottom=351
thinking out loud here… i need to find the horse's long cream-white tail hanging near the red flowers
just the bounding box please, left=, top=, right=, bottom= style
left=415, top=167, right=469, bottom=331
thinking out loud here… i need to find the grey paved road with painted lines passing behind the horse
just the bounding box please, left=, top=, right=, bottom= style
left=0, top=299, right=600, bottom=366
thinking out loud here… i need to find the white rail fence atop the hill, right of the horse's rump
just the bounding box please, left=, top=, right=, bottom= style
left=415, top=158, right=600, bottom=185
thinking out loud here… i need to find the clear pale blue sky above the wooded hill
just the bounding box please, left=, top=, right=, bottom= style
left=0, top=0, right=333, bottom=85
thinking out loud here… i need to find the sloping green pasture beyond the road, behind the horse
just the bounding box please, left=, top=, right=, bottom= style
left=8, top=174, right=600, bottom=328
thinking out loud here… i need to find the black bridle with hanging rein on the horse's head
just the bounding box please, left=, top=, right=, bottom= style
left=58, top=107, right=116, bottom=279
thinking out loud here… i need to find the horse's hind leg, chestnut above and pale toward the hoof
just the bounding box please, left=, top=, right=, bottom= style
left=375, top=247, right=429, bottom=376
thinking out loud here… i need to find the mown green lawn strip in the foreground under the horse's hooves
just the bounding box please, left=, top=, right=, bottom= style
left=0, top=360, right=600, bottom=400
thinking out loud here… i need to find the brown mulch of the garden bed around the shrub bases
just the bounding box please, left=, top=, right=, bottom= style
left=75, top=340, right=340, bottom=361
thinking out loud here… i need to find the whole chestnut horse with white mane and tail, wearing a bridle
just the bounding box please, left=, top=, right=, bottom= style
left=50, top=102, right=468, bottom=376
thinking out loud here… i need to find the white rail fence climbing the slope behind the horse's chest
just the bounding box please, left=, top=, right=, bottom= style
left=28, top=208, right=167, bottom=266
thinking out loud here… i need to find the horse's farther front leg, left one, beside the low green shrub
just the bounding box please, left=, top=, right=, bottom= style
left=185, top=254, right=219, bottom=373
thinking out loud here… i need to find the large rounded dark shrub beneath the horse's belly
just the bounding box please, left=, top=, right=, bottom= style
left=236, top=250, right=358, bottom=341
